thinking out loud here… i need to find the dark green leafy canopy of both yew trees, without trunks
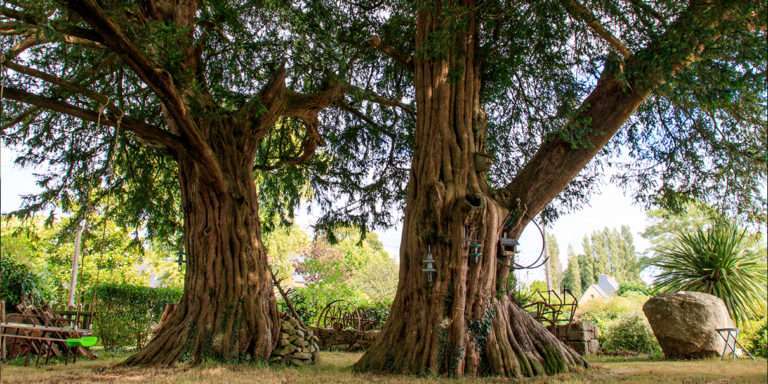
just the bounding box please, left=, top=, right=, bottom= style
left=1, top=1, right=768, bottom=237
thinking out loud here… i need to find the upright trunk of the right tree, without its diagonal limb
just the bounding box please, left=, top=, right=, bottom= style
left=355, top=5, right=585, bottom=377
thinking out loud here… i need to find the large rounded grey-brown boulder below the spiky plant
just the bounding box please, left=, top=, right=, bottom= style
left=643, top=291, right=733, bottom=359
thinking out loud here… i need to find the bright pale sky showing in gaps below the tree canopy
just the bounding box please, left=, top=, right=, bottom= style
left=0, top=143, right=649, bottom=281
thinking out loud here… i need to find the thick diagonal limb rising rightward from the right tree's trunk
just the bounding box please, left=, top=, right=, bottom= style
left=495, top=1, right=743, bottom=236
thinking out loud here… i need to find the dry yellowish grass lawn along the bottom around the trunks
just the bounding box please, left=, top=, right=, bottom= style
left=2, top=352, right=768, bottom=384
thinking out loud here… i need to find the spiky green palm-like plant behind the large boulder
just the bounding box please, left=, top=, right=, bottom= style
left=651, top=222, right=766, bottom=323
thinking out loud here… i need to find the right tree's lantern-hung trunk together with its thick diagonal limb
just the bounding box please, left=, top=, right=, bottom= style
left=355, top=0, right=736, bottom=377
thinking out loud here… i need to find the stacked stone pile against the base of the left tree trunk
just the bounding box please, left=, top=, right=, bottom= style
left=270, top=314, right=320, bottom=365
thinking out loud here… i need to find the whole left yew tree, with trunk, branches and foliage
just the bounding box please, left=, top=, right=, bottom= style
left=0, top=0, right=409, bottom=365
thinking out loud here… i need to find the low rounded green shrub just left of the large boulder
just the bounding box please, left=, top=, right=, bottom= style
left=600, top=314, right=661, bottom=354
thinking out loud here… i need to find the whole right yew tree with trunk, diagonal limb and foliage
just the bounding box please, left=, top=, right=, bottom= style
left=356, top=0, right=766, bottom=377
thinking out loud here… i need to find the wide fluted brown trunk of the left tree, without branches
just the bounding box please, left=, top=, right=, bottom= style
left=125, top=117, right=279, bottom=366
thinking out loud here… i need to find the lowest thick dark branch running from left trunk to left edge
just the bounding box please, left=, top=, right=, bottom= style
left=3, top=87, right=183, bottom=153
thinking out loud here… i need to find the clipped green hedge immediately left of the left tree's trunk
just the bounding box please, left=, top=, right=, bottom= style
left=92, top=284, right=182, bottom=350
